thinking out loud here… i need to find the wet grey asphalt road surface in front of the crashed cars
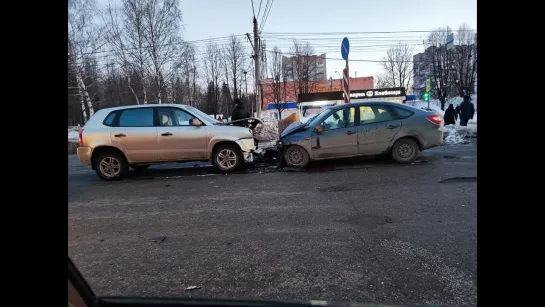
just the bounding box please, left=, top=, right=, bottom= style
left=68, top=144, right=477, bottom=306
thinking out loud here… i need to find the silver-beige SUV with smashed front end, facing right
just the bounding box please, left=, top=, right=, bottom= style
left=77, top=104, right=256, bottom=180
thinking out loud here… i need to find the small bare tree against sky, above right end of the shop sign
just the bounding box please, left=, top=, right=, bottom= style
left=378, top=43, right=414, bottom=89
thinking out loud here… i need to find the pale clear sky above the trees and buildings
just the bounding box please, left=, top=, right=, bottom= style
left=180, top=0, right=477, bottom=83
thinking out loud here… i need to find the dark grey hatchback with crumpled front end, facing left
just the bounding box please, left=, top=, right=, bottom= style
left=278, top=101, right=443, bottom=168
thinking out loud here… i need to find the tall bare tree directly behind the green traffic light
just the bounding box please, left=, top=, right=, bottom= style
left=425, top=27, right=456, bottom=110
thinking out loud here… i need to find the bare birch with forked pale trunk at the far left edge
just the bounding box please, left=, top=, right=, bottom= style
left=68, top=0, right=100, bottom=122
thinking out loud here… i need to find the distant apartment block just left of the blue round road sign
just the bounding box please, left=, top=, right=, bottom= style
left=282, top=53, right=327, bottom=82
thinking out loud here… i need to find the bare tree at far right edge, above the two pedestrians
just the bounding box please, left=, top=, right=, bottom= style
left=453, top=24, right=477, bottom=96
